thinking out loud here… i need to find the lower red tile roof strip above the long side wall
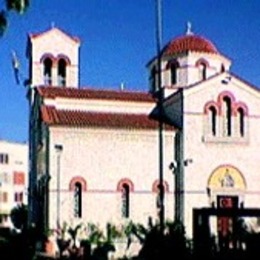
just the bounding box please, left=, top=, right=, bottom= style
left=41, top=106, right=173, bottom=129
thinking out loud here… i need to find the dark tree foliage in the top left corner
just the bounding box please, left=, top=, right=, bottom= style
left=0, top=0, right=30, bottom=36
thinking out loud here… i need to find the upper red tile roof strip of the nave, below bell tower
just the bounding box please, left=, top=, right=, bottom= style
left=37, top=86, right=155, bottom=103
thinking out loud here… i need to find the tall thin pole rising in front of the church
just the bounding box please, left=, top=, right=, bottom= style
left=155, top=0, right=165, bottom=233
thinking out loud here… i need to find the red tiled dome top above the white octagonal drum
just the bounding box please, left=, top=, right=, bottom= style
left=162, top=34, right=219, bottom=56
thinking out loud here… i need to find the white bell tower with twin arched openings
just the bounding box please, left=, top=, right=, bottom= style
left=27, top=26, right=80, bottom=88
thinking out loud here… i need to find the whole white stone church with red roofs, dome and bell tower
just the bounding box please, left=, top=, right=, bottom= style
left=27, top=24, right=260, bottom=244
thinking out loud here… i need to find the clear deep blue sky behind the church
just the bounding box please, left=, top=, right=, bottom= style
left=0, top=0, right=260, bottom=142
